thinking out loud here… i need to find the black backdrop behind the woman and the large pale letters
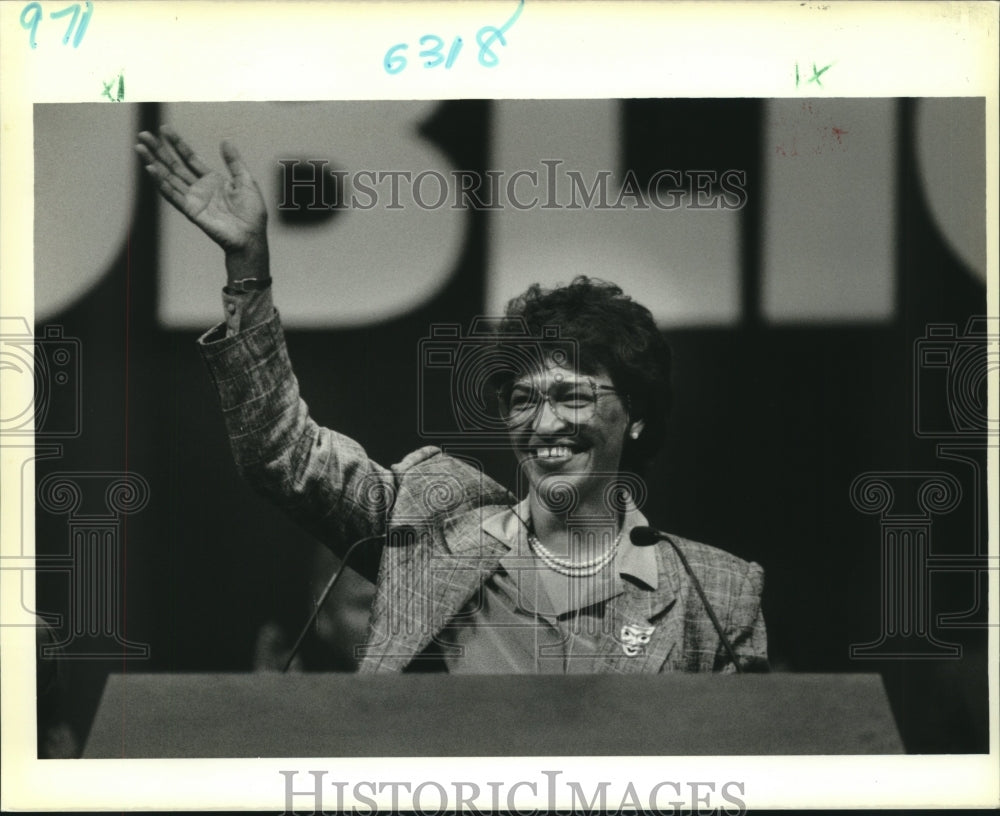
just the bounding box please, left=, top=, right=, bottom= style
left=36, top=99, right=988, bottom=756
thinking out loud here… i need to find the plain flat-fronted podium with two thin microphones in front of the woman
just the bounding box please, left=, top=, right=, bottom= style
left=83, top=673, right=903, bottom=759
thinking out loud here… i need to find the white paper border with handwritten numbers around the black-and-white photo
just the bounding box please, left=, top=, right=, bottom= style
left=0, top=0, right=1000, bottom=810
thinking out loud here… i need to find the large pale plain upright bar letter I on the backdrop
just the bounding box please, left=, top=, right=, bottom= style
left=761, top=99, right=896, bottom=323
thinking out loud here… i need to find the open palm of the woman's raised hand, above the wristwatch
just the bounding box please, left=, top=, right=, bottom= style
left=136, top=126, right=267, bottom=252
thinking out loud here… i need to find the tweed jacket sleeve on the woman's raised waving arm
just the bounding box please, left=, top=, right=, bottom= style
left=199, top=311, right=395, bottom=578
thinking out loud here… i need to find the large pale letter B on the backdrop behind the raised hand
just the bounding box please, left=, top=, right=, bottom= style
left=159, top=102, right=466, bottom=328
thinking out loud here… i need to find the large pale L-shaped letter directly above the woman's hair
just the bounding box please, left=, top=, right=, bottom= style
left=487, top=100, right=740, bottom=326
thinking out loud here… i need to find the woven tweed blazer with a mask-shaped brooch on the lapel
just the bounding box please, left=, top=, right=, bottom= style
left=199, top=313, right=767, bottom=673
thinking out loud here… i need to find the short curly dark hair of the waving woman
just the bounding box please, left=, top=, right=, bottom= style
left=501, top=275, right=673, bottom=470
